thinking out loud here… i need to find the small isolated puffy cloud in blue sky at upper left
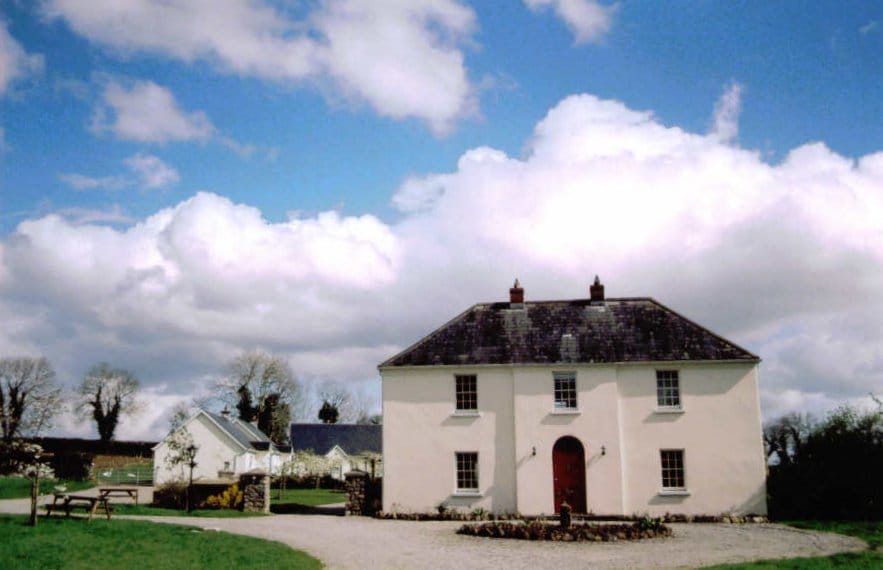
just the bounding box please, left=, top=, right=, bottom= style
left=92, top=80, right=216, bottom=143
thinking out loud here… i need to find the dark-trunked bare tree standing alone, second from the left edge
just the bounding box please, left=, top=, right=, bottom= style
left=77, top=362, right=139, bottom=444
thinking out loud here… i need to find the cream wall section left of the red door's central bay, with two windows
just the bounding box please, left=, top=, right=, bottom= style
left=383, top=367, right=516, bottom=512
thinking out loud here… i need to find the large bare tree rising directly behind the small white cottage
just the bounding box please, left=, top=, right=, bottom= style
left=215, top=350, right=304, bottom=443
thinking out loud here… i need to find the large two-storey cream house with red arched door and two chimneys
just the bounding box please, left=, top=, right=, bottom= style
left=379, top=277, right=766, bottom=515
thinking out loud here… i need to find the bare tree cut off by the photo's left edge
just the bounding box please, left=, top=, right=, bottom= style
left=0, top=357, right=61, bottom=443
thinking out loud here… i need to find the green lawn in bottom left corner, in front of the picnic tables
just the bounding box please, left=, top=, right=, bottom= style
left=0, top=515, right=322, bottom=570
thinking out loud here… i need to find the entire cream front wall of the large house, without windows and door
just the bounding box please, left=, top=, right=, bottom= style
left=381, top=363, right=766, bottom=515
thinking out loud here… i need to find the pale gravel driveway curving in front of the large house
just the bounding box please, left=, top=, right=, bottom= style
left=0, top=494, right=867, bottom=570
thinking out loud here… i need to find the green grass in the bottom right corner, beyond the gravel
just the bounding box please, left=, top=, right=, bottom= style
left=707, top=521, right=883, bottom=570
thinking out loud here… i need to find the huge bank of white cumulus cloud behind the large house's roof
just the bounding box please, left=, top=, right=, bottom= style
left=0, top=95, right=883, bottom=434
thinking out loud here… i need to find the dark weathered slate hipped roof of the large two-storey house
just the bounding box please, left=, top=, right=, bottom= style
left=380, top=298, right=759, bottom=368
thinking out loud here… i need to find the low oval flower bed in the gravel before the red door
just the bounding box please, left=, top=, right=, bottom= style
left=457, top=519, right=671, bottom=542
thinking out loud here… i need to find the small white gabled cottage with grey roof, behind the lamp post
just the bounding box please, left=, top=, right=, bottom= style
left=153, top=410, right=291, bottom=485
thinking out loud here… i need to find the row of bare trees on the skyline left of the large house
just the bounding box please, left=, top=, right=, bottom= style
left=0, top=350, right=380, bottom=452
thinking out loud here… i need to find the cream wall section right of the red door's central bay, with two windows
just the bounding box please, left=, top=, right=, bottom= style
left=619, top=363, right=766, bottom=515
